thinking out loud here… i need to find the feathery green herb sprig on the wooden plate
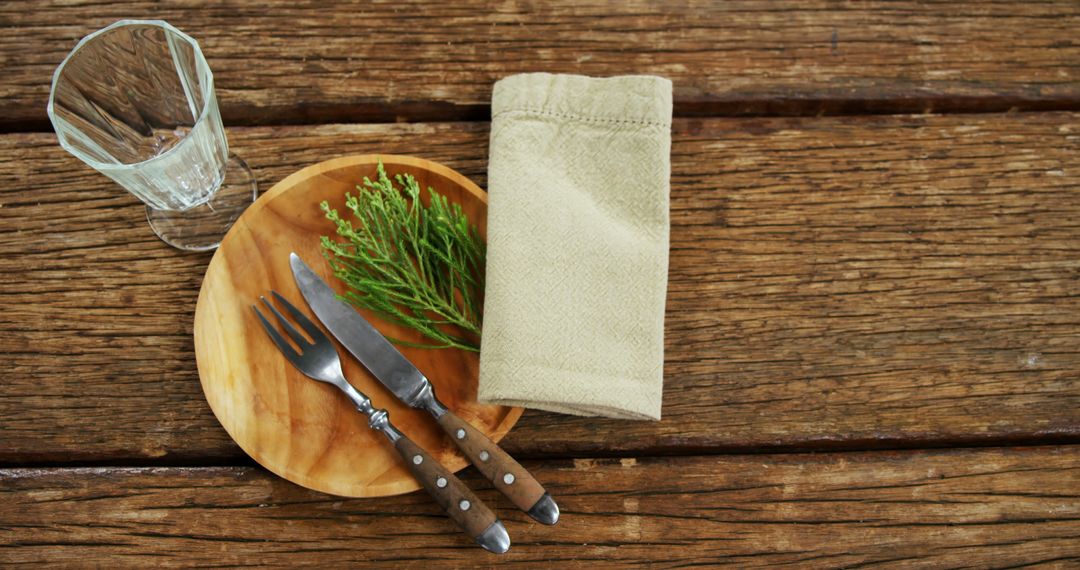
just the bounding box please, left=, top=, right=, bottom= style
left=321, top=161, right=485, bottom=352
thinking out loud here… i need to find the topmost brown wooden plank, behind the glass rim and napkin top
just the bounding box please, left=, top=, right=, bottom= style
left=0, top=0, right=1080, bottom=130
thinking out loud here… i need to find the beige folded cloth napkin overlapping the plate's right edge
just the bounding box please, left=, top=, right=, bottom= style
left=480, top=73, right=672, bottom=420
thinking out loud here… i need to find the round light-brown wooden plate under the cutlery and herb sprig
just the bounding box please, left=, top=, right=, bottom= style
left=194, top=154, right=522, bottom=497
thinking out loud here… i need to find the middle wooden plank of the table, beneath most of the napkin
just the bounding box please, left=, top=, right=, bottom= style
left=0, top=113, right=1080, bottom=462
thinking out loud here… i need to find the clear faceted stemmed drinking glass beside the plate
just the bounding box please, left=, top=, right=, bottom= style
left=49, top=19, right=258, bottom=250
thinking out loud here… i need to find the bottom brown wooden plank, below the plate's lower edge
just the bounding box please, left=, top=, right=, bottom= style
left=0, top=448, right=1080, bottom=568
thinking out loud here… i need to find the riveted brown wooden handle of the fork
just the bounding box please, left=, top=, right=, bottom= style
left=394, top=435, right=510, bottom=553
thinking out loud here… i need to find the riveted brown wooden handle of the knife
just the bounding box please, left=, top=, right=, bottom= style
left=437, top=410, right=558, bottom=525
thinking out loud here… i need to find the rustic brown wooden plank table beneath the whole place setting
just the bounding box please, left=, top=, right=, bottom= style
left=0, top=0, right=1080, bottom=568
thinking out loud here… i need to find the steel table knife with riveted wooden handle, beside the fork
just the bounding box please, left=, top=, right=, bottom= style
left=289, top=253, right=558, bottom=525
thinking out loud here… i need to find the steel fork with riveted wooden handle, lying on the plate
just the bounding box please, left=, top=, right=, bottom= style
left=252, top=290, right=510, bottom=554
